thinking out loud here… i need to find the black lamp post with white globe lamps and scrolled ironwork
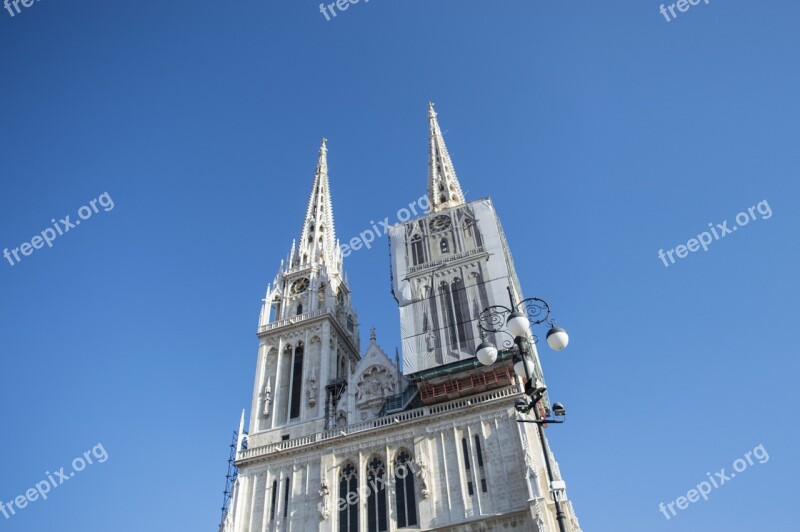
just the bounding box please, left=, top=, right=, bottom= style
left=475, top=286, right=569, bottom=532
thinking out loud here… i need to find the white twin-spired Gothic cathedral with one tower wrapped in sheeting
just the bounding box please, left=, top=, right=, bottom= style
left=220, top=104, right=580, bottom=532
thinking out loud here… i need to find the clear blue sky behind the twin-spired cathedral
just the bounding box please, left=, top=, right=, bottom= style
left=0, top=0, right=800, bottom=532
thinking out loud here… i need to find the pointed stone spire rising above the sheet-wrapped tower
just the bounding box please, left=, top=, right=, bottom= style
left=428, top=103, right=464, bottom=212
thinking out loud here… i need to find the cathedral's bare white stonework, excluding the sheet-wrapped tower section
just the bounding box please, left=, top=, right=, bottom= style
left=220, top=107, right=580, bottom=532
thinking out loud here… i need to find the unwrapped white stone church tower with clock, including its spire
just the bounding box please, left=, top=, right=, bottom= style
left=250, top=139, right=359, bottom=436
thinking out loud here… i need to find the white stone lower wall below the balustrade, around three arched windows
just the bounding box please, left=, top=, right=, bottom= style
left=233, top=398, right=578, bottom=532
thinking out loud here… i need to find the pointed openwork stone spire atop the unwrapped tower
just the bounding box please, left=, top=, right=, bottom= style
left=297, top=139, right=339, bottom=266
